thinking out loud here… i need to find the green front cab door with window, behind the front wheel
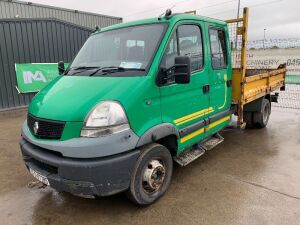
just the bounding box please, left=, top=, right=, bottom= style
left=160, top=21, right=211, bottom=152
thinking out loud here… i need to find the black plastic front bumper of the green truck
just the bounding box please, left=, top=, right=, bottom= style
left=20, top=138, right=139, bottom=196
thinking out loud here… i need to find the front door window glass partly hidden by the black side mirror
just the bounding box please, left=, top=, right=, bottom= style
left=161, top=25, right=203, bottom=84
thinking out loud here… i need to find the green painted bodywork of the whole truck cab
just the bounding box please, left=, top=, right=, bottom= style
left=29, top=14, right=232, bottom=152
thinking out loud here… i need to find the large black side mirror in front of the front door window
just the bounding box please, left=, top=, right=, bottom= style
left=174, top=56, right=191, bottom=84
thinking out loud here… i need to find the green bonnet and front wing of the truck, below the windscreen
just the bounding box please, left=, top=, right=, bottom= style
left=29, top=76, right=161, bottom=139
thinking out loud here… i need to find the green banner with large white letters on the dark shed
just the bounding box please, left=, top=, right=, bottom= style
left=15, top=63, right=68, bottom=93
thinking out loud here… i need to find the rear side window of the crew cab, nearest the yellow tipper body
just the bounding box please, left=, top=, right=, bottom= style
left=209, top=28, right=227, bottom=69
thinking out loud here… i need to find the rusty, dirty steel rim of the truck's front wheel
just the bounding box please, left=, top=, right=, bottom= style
left=143, top=159, right=166, bottom=193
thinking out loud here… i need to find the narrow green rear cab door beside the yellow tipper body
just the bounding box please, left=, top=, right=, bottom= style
left=205, top=23, right=232, bottom=136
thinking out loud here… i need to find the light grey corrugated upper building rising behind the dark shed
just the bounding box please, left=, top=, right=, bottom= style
left=0, top=0, right=122, bottom=29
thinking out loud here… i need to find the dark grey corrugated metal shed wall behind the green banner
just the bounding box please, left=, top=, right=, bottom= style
left=0, top=19, right=92, bottom=111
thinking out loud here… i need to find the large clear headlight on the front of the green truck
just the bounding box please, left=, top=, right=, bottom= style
left=81, top=101, right=129, bottom=137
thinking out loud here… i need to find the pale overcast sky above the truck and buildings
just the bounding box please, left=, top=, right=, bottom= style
left=32, top=0, right=300, bottom=40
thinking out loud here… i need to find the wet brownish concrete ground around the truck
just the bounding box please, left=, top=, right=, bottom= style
left=0, top=108, right=300, bottom=225
